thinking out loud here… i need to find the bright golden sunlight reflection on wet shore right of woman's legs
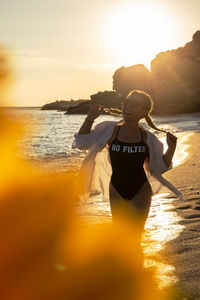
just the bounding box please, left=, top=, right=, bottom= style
left=142, top=193, right=184, bottom=288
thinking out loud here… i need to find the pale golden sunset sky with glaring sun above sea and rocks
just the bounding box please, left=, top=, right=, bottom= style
left=0, top=0, right=200, bottom=106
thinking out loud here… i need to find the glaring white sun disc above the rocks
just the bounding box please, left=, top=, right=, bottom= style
left=103, top=5, right=175, bottom=68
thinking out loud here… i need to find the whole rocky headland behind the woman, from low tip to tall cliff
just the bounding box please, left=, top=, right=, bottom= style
left=42, top=31, right=200, bottom=115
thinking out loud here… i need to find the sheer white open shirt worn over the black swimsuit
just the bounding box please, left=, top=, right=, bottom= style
left=72, top=120, right=182, bottom=202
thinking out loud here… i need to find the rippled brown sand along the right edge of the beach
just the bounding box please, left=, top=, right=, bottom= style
left=161, top=132, right=200, bottom=299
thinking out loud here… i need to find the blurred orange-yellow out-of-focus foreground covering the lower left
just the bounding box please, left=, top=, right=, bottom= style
left=0, top=47, right=184, bottom=300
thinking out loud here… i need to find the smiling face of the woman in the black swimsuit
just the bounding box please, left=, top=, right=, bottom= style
left=122, top=97, right=147, bottom=121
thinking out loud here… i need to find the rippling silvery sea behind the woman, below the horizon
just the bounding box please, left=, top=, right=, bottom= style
left=4, top=108, right=200, bottom=171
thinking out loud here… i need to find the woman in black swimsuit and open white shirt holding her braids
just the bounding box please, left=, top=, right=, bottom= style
left=72, top=90, right=181, bottom=228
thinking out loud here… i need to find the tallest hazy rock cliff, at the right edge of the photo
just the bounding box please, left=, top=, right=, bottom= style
left=151, top=31, right=200, bottom=114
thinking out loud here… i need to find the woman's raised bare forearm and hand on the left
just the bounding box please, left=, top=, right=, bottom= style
left=78, top=103, right=103, bottom=134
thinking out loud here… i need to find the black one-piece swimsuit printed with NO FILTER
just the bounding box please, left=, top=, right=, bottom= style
left=109, top=126, right=148, bottom=200
